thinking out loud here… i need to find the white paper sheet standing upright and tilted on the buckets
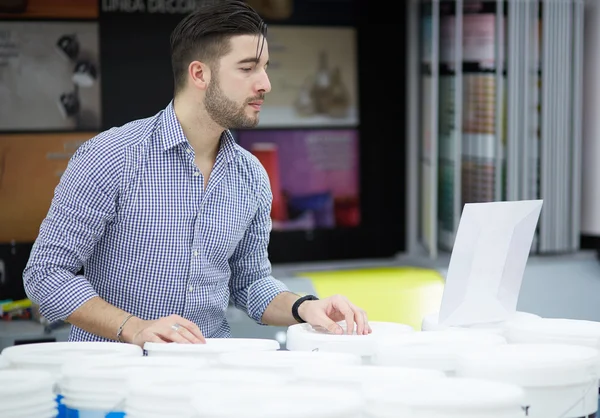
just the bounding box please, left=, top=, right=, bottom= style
left=439, top=200, right=543, bottom=326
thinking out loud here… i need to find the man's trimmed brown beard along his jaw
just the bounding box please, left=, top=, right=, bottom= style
left=204, top=77, right=258, bottom=129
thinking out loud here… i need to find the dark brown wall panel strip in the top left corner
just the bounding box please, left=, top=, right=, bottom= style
left=0, top=0, right=98, bottom=19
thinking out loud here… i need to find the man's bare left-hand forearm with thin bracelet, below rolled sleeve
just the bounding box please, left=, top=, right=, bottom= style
left=67, top=297, right=140, bottom=342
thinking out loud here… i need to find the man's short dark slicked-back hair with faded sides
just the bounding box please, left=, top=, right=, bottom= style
left=171, top=0, right=267, bottom=94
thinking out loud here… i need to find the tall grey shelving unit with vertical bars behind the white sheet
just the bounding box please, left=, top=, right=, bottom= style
left=407, top=0, right=585, bottom=258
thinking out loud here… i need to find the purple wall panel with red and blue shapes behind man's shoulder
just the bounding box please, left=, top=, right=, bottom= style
left=237, top=130, right=360, bottom=231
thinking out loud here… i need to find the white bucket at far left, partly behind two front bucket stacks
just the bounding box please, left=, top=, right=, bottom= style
left=2, top=341, right=144, bottom=418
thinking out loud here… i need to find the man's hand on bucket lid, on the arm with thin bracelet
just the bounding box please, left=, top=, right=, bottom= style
left=123, top=315, right=206, bottom=348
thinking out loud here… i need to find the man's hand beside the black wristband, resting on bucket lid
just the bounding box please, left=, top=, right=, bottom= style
left=298, top=295, right=373, bottom=335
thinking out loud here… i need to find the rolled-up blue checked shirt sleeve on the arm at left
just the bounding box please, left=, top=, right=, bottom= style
left=23, top=137, right=123, bottom=322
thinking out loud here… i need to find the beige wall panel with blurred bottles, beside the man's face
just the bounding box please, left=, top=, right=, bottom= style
left=258, top=25, right=359, bottom=128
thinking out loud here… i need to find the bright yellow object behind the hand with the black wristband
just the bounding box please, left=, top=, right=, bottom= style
left=298, top=267, right=444, bottom=331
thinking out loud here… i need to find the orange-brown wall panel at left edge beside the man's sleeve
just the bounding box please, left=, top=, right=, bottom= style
left=0, top=132, right=95, bottom=243
